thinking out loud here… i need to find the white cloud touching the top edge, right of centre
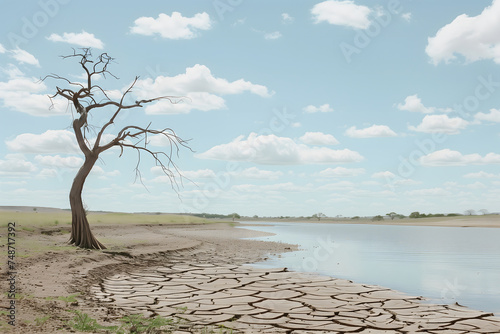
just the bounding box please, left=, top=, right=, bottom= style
left=311, top=0, right=372, bottom=29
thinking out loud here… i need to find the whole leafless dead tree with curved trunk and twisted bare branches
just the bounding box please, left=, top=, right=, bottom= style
left=42, top=49, right=190, bottom=249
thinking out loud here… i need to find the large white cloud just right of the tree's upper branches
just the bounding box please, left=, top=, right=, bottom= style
left=134, top=64, right=274, bottom=114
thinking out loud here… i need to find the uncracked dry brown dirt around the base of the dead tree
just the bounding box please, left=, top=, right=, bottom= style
left=0, top=218, right=294, bottom=333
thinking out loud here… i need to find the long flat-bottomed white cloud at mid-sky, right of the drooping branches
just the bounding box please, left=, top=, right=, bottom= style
left=197, top=133, right=363, bottom=165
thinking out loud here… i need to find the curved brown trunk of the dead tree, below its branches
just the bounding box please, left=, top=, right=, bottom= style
left=69, top=153, right=106, bottom=249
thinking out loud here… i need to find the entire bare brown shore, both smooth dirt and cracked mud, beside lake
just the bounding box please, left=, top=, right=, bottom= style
left=0, top=214, right=500, bottom=334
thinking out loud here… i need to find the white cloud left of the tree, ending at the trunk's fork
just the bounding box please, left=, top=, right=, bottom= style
left=6, top=130, right=80, bottom=154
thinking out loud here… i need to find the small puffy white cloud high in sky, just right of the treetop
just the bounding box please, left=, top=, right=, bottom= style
left=130, top=12, right=212, bottom=39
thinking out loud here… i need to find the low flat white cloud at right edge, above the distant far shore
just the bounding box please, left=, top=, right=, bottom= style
left=420, top=149, right=500, bottom=166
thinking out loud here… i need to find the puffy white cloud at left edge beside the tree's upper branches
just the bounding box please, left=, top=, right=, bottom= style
left=0, top=76, right=68, bottom=116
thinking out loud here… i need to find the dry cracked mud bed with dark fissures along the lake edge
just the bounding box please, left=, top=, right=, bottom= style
left=91, top=257, right=500, bottom=334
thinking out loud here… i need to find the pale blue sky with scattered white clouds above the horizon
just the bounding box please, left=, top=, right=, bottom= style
left=0, top=0, right=500, bottom=217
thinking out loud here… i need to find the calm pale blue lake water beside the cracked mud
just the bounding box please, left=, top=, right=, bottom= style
left=242, top=222, right=500, bottom=315
